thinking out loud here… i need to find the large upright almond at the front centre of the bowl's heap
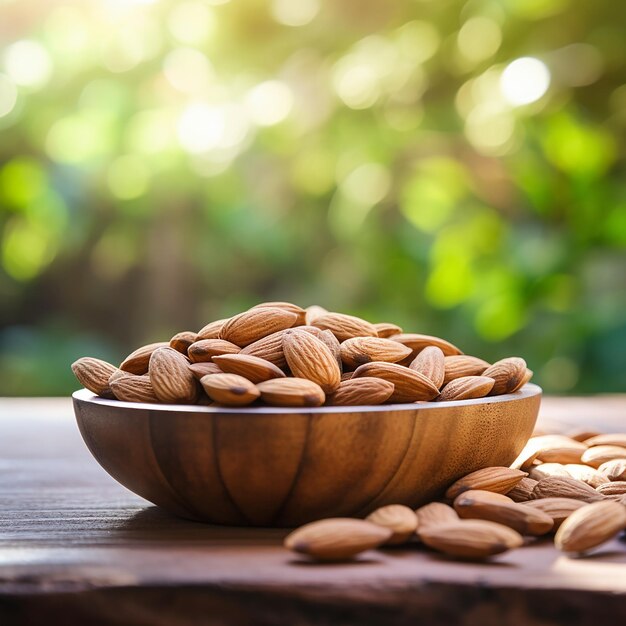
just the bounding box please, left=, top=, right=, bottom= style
left=283, top=330, right=341, bottom=393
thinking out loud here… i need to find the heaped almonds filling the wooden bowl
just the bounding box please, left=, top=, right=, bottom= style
left=72, top=302, right=532, bottom=407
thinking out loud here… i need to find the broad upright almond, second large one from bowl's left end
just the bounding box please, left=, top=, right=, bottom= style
left=148, top=347, right=198, bottom=403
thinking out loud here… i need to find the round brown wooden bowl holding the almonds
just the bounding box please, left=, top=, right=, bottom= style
left=73, top=384, right=541, bottom=527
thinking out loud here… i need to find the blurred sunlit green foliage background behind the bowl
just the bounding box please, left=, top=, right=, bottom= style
left=0, top=0, right=626, bottom=395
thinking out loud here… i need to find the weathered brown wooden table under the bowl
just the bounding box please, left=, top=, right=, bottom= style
left=0, top=397, right=626, bottom=626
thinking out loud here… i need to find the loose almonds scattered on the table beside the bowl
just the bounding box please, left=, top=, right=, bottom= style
left=285, top=432, right=626, bottom=561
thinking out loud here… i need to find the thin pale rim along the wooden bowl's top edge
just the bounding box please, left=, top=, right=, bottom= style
left=72, top=383, right=542, bottom=415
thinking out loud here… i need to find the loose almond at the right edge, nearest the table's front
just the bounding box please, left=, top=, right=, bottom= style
left=554, top=501, right=626, bottom=552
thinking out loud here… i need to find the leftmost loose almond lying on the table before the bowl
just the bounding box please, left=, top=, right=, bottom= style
left=284, top=517, right=392, bottom=561
